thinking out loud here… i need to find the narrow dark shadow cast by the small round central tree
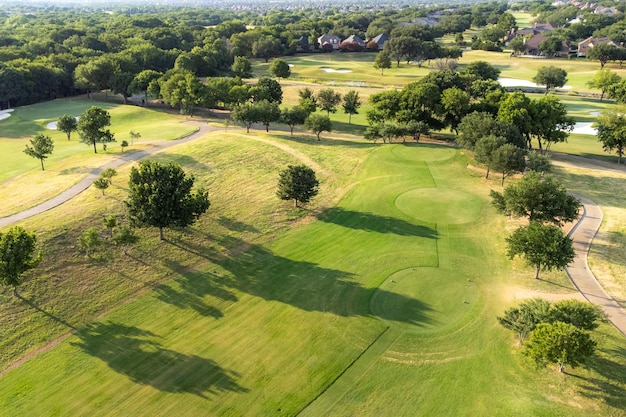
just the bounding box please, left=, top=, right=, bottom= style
left=317, top=207, right=437, bottom=239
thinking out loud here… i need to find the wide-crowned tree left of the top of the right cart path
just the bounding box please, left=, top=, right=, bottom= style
left=491, top=171, right=580, bottom=226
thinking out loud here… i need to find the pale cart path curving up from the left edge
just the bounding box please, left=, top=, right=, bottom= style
left=0, top=121, right=216, bottom=227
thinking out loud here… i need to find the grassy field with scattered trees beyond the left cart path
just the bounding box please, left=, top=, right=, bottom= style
left=0, top=99, right=195, bottom=217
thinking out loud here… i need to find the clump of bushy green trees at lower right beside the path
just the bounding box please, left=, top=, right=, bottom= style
left=498, top=298, right=606, bottom=372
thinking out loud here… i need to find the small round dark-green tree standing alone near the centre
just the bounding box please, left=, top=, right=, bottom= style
left=276, top=165, right=319, bottom=208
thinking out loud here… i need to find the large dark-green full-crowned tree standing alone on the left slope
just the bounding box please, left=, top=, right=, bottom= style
left=126, top=161, right=210, bottom=240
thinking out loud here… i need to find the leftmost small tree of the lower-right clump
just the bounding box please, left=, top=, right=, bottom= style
left=497, top=298, right=550, bottom=346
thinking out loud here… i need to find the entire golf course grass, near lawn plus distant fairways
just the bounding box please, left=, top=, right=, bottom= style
left=0, top=51, right=626, bottom=416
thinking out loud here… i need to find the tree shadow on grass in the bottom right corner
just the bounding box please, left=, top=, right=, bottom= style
left=569, top=347, right=626, bottom=410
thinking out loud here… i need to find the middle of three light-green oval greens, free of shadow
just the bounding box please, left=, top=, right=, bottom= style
left=395, top=187, right=483, bottom=224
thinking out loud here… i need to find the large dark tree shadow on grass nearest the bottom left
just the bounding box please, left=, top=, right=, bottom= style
left=72, top=322, right=248, bottom=398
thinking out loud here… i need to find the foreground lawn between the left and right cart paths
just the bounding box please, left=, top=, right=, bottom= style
left=0, top=128, right=626, bottom=416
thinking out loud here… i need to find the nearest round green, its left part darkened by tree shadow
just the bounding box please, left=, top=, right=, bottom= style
left=370, top=267, right=478, bottom=332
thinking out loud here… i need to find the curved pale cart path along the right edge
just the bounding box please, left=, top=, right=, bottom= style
left=565, top=196, right=626, bottom=336
